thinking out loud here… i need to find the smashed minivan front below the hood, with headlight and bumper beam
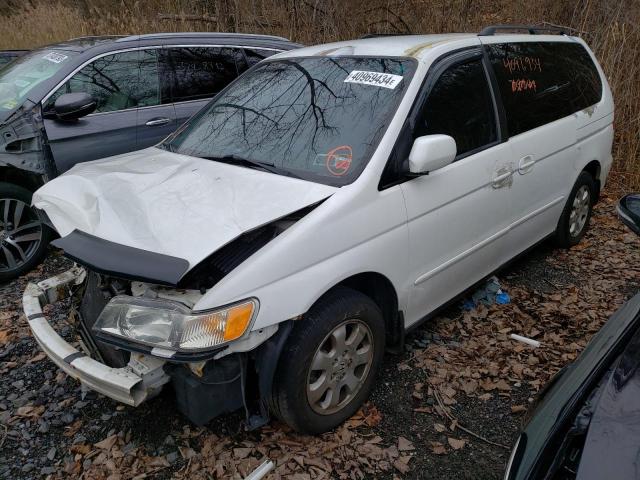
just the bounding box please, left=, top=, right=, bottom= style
left=23, top=266, right=290, bottom=428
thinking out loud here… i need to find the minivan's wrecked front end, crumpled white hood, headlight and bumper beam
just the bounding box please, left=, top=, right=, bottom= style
left=24, top=142, right=337, bottom=428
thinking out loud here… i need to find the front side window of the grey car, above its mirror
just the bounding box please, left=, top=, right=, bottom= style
left=45, top=50, right=160, bottom=113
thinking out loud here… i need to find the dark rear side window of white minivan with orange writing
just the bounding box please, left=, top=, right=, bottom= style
left=486, top=42, right=602, bottom=136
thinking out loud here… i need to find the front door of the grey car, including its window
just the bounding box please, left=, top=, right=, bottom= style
left=43, top=50, right=165, bottom=173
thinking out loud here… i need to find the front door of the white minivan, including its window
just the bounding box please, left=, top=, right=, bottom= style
left=401, top=50, right=513, bottom=325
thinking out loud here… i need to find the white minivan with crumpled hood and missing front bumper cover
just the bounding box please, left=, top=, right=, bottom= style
left=24, top=27, right=613, bottom=433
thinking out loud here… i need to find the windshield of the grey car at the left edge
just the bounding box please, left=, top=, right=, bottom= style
left=0, top=50, right=75, bottom=114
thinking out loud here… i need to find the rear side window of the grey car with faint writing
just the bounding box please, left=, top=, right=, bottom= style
left=161, top=47, right=244, bottom=102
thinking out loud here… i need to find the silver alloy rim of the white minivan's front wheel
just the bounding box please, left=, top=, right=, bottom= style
left=307, top=319, right=374, bottom=415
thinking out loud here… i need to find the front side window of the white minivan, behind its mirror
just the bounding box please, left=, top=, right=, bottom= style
left=414, top=59, right=497, bottom=156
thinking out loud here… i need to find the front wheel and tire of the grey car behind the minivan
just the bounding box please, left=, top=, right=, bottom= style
left=0, top=182, right=52, bottom=283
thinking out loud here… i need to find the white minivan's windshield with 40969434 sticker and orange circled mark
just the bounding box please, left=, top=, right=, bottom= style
left=164, top=57, right=415, bottom=186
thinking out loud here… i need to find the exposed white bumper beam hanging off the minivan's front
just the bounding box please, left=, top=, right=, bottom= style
left=22, top=266, right=170, bottom=406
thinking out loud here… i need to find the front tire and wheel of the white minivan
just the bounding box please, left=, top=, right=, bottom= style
left=270, top=287, right=385, bottom=434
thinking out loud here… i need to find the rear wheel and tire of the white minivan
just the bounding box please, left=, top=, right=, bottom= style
left=555, top=171, right=596, bottom=248
